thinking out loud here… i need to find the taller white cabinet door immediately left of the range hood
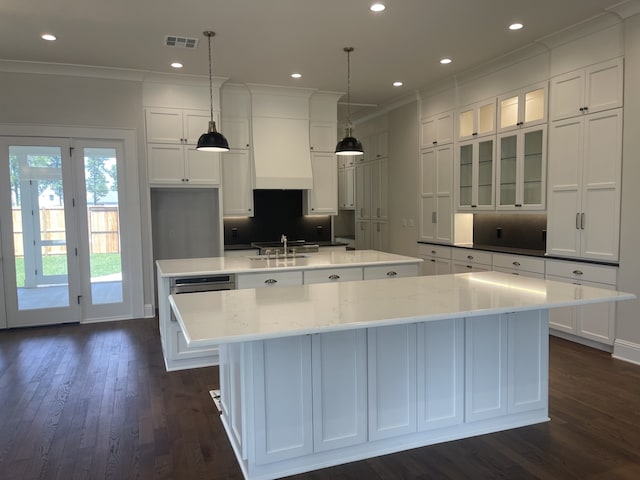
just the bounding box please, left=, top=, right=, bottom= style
left=222, top=150, right=253, bottom=217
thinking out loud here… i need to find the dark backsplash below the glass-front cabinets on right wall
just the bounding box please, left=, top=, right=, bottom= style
left=473, top=213, right=547, bottom=251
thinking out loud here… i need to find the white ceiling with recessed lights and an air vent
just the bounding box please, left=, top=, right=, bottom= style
left=0, top=0, right=632, bottom=117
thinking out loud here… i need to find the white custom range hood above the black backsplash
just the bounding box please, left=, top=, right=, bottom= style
left=247, top=84, right=314, bottom=190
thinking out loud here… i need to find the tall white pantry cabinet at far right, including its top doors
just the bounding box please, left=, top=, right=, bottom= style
left=547, top=60, right=622, bottom=262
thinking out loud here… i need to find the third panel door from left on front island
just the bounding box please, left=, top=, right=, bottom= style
left=367, top=324, right=416, bottom=441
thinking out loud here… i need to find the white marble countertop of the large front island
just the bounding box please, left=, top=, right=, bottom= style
left=169, top=272, right=635, bottom=347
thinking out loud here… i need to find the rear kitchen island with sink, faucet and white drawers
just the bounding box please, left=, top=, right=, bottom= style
left=156, top=250, right=422, bottom=371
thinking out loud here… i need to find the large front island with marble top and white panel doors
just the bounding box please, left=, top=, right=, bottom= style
left=170, top=272, right=634, bottom=479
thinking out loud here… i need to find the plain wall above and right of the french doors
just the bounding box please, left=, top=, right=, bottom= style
left=0, top=72, right=153, bottom=312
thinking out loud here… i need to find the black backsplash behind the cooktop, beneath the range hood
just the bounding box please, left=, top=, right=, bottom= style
left=224, top=190, right=331, bottom=245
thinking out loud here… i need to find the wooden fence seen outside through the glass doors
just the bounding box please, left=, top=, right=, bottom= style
left=12, top=205, right=120, bottom=257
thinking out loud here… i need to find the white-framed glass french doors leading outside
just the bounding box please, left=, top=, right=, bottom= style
left=0, top=137, right=130, bottom=327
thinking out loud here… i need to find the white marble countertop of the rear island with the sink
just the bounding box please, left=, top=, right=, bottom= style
left=156, top=250, right=423, bottom=277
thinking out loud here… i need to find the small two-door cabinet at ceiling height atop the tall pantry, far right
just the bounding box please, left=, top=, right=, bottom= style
left=549, top=58, right=623, bottom=120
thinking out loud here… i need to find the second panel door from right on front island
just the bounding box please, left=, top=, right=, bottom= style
left=465, top=315, right=507, bottom=422
